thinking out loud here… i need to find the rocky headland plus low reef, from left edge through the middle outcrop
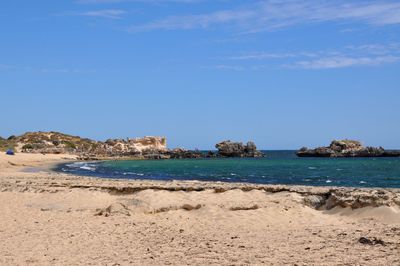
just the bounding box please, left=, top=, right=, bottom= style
left=0, top=132, right=264, bottom=160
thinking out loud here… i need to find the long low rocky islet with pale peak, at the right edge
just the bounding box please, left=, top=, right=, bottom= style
left=296, top=140, right=400, bottom=157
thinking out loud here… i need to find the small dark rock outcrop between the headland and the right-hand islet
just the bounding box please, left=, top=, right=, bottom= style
left=215, top=140, right=263, bottom=157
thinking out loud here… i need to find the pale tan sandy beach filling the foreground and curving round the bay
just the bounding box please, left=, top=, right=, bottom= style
left=0, top=154, right=400, bottom=265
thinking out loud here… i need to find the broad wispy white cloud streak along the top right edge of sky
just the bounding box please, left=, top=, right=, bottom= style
left=129, top=0, right=400, bottom=33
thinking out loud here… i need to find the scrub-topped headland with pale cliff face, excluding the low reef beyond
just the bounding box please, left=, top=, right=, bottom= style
left=7, top=132, right=167, bottom=157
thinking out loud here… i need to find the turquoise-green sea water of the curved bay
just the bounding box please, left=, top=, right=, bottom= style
left=56, top=151, right=400, bottom=188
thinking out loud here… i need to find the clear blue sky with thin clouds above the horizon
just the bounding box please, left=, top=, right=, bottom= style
left=0, top=0, right=400, bottom=149
